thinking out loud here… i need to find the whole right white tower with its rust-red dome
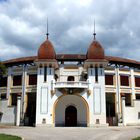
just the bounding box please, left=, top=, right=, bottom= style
left=84, top=27, right=108, bottom=125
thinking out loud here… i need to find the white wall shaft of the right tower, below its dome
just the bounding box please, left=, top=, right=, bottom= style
left=88, top=68, right=106, bottom=126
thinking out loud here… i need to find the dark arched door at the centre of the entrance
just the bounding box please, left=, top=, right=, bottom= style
left=65, top=106, right=77, bottom=126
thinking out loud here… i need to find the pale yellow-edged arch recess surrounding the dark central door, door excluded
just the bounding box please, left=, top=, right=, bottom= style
left=53, top=95, right=89, bottom=126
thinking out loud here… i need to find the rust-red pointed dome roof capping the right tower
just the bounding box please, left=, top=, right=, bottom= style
left=87, top=40, right=104, bottom=59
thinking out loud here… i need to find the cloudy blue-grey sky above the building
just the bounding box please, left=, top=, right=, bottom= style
left=0, top=0, right=140, bottom=61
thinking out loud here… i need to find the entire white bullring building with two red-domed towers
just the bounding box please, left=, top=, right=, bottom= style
left=0, top=33, right=140, bottom=127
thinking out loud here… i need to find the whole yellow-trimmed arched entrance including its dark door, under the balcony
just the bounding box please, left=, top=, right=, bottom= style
left=54, top=95, right=89, bottom=127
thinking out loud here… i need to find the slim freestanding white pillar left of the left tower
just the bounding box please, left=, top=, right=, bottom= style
left=16, top=94, right=21, bottom=126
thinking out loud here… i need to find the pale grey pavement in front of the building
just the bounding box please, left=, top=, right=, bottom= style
left=0, top=126, right=140, bottom=140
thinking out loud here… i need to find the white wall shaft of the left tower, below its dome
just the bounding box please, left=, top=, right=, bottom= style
left=36, top=68, right=54, bottom=126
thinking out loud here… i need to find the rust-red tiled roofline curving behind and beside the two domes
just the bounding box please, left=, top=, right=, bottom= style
left=2, top=54, right=140, bottom=68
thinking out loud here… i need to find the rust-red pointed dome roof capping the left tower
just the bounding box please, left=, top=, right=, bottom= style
left=38, top=39, right=56, bottom=59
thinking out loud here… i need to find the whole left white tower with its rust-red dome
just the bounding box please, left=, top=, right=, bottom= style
left=35, top=29, right=58, bottom=125
